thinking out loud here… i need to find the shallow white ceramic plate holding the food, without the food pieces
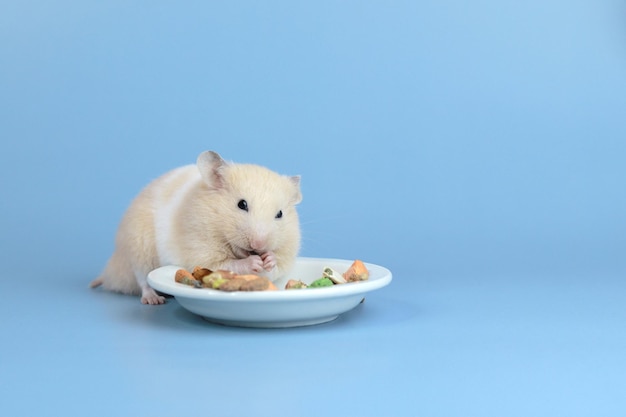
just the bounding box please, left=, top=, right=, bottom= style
left=148, top=258, right=391, bottom=327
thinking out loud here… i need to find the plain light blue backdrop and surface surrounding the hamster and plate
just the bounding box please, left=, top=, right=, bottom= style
left=0, top=0, right=626, bottom=416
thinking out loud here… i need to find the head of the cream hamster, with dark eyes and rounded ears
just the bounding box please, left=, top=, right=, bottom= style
left=197, top=151, right=302, bottom=258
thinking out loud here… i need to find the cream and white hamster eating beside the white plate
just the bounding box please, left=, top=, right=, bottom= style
left=90, top=151, right=302, bottom=304
